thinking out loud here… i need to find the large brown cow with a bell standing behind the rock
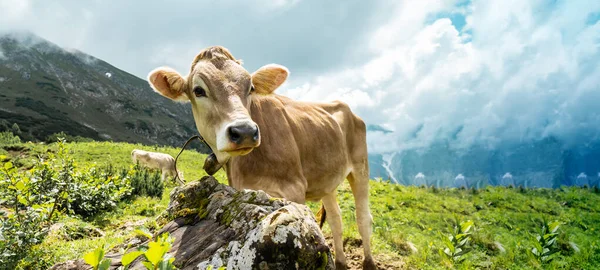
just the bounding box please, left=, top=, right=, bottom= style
left=148, top=46, right=376, bottom=269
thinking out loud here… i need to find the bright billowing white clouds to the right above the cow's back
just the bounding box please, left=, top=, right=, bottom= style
left=281, top=1, right=600, bottom=152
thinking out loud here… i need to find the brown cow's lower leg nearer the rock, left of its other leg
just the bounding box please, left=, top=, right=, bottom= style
left=322, top=190, right=347, bottom=269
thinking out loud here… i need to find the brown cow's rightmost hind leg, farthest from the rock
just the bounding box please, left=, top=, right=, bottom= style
left=346, top=167, right=377, bottom=269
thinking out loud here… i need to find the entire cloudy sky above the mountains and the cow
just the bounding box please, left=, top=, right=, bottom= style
left=0, top=0, right=600, bottom=152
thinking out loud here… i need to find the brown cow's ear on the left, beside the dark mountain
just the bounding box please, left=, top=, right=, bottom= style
left=148, top=67, right=189, bottom=102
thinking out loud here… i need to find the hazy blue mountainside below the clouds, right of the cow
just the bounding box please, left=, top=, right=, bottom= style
left=369, top=137, right=600, bottom=188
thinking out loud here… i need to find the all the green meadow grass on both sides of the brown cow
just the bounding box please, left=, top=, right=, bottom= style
left=0, top=142, right=600, bottom=269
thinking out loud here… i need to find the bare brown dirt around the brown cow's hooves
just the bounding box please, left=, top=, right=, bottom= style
left=325, top=234, right=408, bottom=270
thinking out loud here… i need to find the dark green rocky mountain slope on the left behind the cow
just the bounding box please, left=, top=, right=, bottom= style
left=0, top=32, right=209, bottom=152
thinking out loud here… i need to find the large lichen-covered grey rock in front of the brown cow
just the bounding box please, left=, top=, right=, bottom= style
left=51, top=176, right=334, bottom=269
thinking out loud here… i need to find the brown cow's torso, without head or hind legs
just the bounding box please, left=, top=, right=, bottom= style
left=227, top=95, right=364, bottom=200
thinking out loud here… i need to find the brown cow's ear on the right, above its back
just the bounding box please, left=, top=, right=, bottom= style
left=252, top=64, right=290, bottom=95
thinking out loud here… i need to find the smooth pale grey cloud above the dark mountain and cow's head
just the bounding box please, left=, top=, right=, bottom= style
left=0, top=0, right=387, bottom=78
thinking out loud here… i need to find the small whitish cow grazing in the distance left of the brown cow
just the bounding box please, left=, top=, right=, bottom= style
left=131, top=149, right=183, bottom=181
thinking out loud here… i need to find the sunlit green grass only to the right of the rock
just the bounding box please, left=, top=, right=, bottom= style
left=311, top=181, right=600, bottom=269
